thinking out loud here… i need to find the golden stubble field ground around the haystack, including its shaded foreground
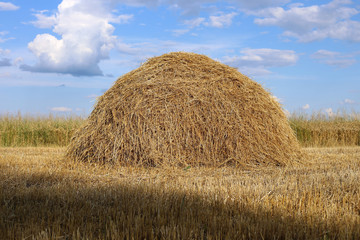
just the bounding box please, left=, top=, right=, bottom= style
left=0, top=147, right=360, bottom=239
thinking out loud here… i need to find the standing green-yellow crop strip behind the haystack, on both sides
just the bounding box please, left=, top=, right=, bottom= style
left=0, top=113, right=360, bottom=147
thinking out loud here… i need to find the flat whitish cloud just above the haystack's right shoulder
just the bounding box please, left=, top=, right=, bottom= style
left=223, top=48, right=298, bottom=75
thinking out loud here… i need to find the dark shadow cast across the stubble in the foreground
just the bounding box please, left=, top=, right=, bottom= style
left=0, top=166, right=359, bottom=239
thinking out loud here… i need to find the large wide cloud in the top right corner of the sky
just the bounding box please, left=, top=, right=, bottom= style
left=253, top=0, right=360, bottom=42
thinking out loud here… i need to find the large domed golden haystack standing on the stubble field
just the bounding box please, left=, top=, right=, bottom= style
left=67, top=52, right=300, bottom=166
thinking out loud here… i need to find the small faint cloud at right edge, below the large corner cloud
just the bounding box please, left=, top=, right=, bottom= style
left=311, top=49, right=359, bottom=68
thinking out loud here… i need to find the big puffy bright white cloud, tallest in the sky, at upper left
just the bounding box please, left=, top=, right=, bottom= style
left=20, top=0, right=132, bottom=76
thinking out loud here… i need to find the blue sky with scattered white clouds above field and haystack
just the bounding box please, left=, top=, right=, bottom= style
left=0, top=0, right=360, bottom=115
